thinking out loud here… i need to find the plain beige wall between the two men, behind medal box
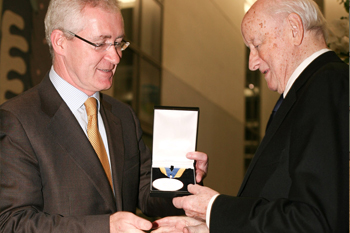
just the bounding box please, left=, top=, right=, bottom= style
left=161, top=0, right=245, bottom=195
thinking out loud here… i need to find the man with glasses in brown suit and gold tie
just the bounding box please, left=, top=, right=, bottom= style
left=0, top=0, right=207, bottom=233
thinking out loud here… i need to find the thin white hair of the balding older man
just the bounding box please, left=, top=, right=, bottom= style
left=270, top=0, right=327, bottom=38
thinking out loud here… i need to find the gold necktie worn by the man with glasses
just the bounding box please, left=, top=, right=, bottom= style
left=84, top=97, right=113, bottom=187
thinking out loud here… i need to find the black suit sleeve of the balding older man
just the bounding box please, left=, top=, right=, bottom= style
left=210, top=64, right=349, bottom=233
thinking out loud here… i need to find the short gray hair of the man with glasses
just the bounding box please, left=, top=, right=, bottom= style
left=44, top=0, right=120, bottom=57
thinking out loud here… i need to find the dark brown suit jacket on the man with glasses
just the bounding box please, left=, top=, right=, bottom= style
left=0, top=75, right=183, bottom=232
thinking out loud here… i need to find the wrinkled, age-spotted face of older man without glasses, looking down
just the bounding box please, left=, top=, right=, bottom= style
left=241, top=4, right=294, bottom=94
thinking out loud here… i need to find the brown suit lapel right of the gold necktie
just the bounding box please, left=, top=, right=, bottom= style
left=101, top=95, right=124, bottom=211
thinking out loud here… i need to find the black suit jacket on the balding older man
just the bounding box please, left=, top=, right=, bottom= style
left=210, top=52, right=349, bottom=233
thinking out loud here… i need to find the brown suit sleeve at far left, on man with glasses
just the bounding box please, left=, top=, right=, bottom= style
left=0, top=109, right=109, bottom=233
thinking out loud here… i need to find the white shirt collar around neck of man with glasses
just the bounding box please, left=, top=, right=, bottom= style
left=49, top=66, right=100, bottom=112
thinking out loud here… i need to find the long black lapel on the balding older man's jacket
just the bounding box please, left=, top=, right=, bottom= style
left=237, top=52, right=340, bottom=196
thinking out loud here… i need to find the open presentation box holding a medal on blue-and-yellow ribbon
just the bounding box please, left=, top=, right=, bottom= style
left=150, top=106, right=199, bottom=197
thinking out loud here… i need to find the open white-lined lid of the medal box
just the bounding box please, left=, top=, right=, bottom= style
left=152, top=106, right=199, bottom=169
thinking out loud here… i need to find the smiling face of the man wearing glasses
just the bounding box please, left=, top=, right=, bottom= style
left=63, top=7, right=124, bottom=96
